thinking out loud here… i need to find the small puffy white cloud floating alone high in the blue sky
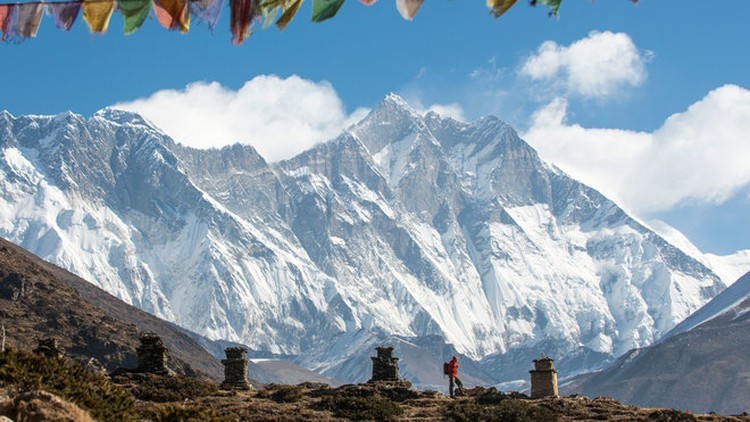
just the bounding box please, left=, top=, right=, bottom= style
left=520, top=31, right=651, bottom=98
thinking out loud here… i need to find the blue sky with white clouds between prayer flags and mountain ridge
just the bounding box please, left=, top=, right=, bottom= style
left=0, top=0, right=750, bottom=254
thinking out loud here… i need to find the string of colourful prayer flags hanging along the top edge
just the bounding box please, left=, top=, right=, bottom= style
left=0, top=0, right=639, bottom=45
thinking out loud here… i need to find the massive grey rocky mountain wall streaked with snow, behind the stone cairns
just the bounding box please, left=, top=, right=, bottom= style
left=0, top=95, right=724, bottom=382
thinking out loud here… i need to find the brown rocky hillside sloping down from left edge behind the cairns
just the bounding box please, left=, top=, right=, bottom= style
left=0, top=239, right=223, bottom=380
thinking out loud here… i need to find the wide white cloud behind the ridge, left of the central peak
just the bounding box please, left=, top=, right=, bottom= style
left=112, top=75, right=367, bottom=161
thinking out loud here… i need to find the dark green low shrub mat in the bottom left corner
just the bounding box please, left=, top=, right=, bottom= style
left=0, top=350, right=137, bottom=421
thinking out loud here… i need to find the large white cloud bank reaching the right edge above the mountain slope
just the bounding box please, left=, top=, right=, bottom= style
left=524, top=85, right=750, bottom=213
